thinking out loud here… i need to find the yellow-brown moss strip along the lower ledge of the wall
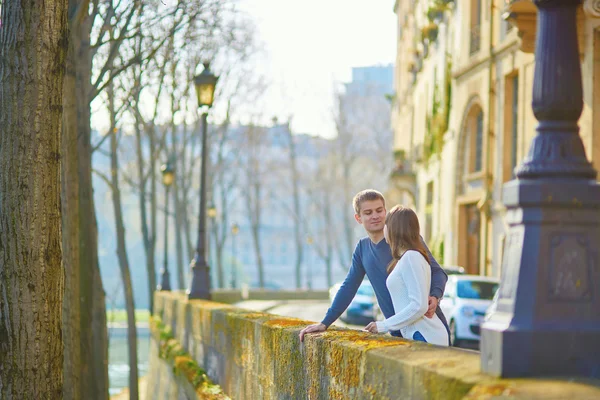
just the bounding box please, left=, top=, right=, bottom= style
left=150, top=316, right=229, bottom=400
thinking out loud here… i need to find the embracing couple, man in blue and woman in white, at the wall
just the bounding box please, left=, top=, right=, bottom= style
left=300, top=189, right=450, bottom=346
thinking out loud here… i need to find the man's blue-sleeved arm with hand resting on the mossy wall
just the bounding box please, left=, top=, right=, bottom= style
left=300, top=242, right=365, bottom=342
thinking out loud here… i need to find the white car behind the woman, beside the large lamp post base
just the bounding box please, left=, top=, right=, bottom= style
left=440, top=275, right=500, bottom=347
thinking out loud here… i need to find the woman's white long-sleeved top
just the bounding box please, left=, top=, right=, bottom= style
left=377, top=250, right=448, bottom=346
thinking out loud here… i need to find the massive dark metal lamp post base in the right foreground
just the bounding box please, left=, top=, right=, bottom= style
left=481, top=0, right=600, bottom=378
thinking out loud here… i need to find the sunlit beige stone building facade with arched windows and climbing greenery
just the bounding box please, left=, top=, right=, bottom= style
left=388, top=0, right=600, bottom=276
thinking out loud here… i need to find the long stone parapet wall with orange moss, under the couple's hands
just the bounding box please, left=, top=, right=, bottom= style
left=149, top=292, right=600, bottom=399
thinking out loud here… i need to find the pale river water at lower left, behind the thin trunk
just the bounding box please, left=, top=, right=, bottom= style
left=108, top=326, right=150, bottom=396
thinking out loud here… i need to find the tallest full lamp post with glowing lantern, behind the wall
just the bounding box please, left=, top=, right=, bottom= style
left=187, top=63, right=219, bottom=299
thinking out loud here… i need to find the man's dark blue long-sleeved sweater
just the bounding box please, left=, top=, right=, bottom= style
left=321, top=237, right=448, bottom=336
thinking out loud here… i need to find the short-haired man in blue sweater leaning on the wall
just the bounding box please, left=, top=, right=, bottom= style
left=300, top=189, right=448, bottom=341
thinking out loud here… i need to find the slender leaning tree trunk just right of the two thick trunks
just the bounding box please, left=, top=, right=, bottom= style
left=108, top=84, right=139, bottom=400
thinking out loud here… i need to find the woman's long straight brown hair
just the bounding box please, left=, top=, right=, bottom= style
left=385, top=205, right=430, bottom=274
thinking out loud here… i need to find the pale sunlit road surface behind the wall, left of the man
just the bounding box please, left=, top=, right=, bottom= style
left=235, top=300, right=364, bottom=329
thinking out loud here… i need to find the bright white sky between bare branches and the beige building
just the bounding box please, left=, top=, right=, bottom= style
left=238, top=0, right=396, bottom=137
